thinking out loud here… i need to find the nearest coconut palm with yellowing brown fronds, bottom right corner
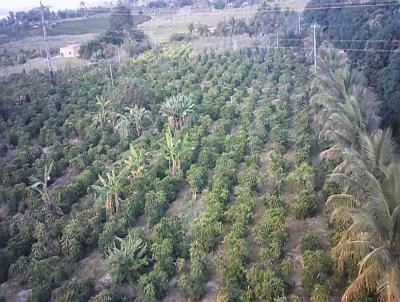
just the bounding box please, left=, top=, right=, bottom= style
left=327, top=163, right=400, bottom=302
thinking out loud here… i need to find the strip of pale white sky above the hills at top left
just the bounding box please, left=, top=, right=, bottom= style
left=0, top=0, right=104, bottom=18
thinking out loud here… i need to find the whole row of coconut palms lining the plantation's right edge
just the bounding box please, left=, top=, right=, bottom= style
left=313, top=45, right=400, bottom=302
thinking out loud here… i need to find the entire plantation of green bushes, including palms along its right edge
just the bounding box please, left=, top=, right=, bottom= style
left=0, top=35, right=398, bottom=302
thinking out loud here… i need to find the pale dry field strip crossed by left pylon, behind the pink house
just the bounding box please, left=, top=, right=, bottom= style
left=0, top=34, right=96, bottom=53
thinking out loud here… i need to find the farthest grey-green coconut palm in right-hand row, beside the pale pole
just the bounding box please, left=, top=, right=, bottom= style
left=310, top=45, right=379, bottom=156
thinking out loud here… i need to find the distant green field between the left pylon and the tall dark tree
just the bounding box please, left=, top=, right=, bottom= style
left=48, top=15, right=110, bottom=36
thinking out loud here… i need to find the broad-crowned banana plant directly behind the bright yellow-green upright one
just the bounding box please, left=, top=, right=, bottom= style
left=160, top=94, right=194, bottom=130
